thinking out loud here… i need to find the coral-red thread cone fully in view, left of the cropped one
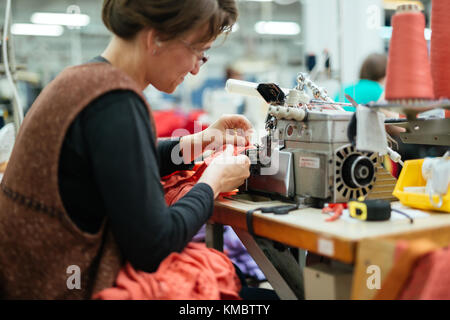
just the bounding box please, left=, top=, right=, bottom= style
left=385, top=5, right=434, bottom=102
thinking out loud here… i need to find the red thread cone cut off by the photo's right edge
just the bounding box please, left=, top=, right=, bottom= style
left=430, top=0, right=450, bottom=99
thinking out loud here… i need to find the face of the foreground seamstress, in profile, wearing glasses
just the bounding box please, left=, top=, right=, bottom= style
left=149, top=30, right=213, bottom=93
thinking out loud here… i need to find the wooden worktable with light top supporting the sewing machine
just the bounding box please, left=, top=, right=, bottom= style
left=207, top=195, right=450, bottom=299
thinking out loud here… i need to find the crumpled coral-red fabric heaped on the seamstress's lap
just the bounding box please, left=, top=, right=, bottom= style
left=93, top=242, right=241, bottom=300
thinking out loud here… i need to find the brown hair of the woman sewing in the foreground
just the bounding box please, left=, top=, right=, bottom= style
left=102, top=0, right=238, bottom=42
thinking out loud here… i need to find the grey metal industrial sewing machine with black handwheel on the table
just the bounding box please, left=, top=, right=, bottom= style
left=226, top=74, right=404, bottom=207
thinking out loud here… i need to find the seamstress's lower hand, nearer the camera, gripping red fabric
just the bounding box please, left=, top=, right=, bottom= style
left=198, top=145, right=250, bottom=198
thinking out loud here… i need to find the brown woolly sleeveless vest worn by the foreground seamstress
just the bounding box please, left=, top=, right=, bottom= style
left=0, top=63, right=156, bottom=299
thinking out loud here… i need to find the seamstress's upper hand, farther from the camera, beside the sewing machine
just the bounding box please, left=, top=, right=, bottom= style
left=180, top=114, right=254, bottom=163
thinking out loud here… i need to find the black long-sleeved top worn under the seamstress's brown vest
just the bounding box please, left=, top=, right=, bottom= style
left=59, top=78, right=214, bottom=272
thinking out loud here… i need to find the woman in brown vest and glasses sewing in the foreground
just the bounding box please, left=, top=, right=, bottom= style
left=0, top=0, right=251, bottom=299
